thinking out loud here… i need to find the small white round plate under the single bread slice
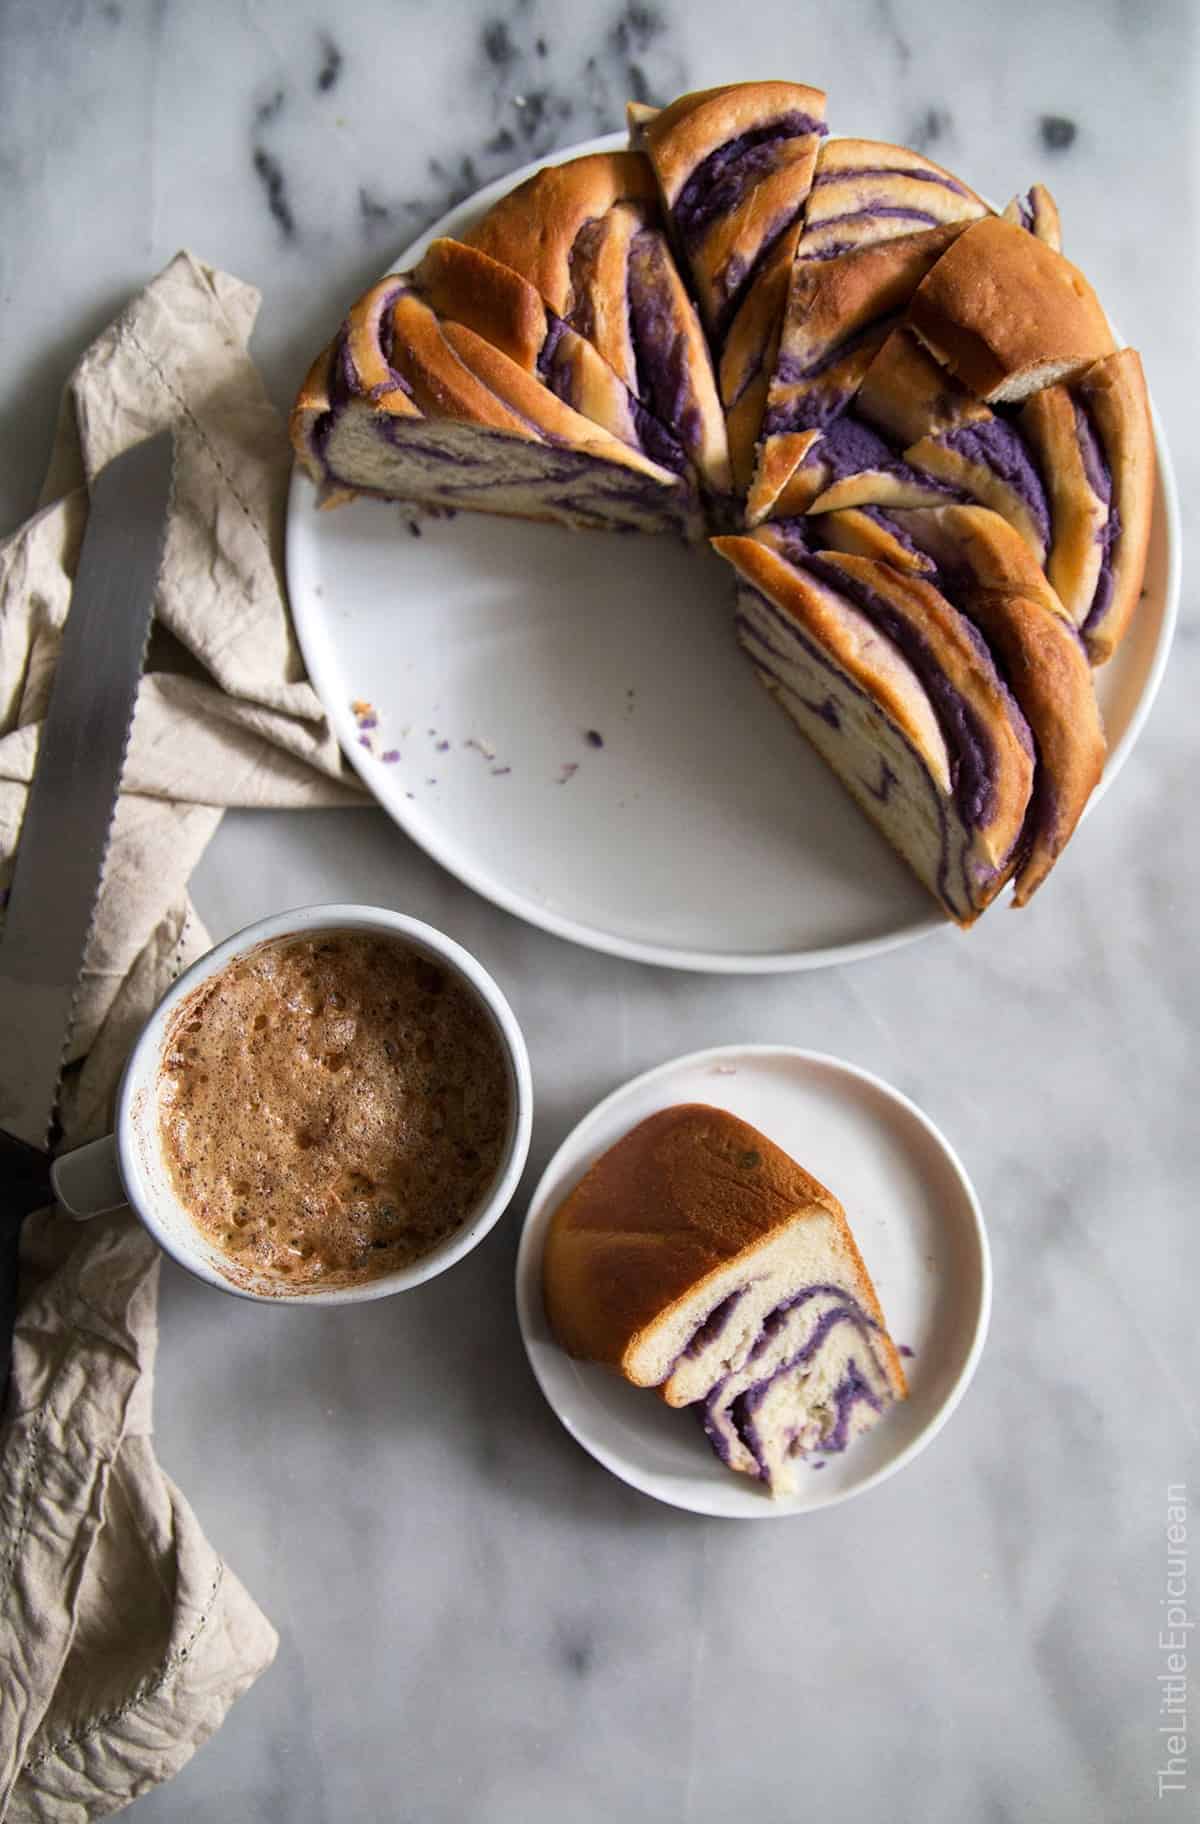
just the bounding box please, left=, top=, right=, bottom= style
left=516, top=1045, right=992, bottom=1519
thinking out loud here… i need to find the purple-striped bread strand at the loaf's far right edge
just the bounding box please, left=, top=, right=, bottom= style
left=1021, top=348, right=1154, bottom=666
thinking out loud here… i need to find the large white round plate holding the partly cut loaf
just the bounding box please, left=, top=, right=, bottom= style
left=286, top=135, right=1178, bottom=972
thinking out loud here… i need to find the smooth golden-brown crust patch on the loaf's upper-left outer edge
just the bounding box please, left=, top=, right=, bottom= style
left=463, top=151, right=658, bottom=317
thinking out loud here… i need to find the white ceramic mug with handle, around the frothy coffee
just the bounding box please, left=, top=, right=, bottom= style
left=51, top=905, right=533, bottom=1304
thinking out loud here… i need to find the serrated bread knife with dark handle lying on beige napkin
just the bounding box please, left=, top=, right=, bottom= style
left=0, top=430, right=173, bottom=1394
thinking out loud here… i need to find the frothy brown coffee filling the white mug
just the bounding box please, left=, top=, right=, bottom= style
left=157, top=930, right=511, bottom=1290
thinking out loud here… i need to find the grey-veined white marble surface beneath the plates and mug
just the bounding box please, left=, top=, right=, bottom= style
left=0, top=0, right=1200, bottom=1824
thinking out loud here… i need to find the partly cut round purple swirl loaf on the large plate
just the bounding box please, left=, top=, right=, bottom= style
left=292, top=82, right=1154, bottom=923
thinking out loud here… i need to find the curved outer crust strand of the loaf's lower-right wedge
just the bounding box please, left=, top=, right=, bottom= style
left=813, top=507, right=1105, bottom=907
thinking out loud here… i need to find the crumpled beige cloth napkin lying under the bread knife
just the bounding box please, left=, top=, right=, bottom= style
left=0, top=254, right=361, bottom=1824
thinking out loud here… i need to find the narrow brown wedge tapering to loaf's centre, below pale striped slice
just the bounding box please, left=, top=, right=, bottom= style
left=746, top=224, right=961, bottom=525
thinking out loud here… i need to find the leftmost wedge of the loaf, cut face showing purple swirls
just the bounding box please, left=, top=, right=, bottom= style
left=290, top=275, right=700, bottom=538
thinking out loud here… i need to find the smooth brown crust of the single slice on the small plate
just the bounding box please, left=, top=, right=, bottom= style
left=542, top=1102, right=886, bottom=1386
